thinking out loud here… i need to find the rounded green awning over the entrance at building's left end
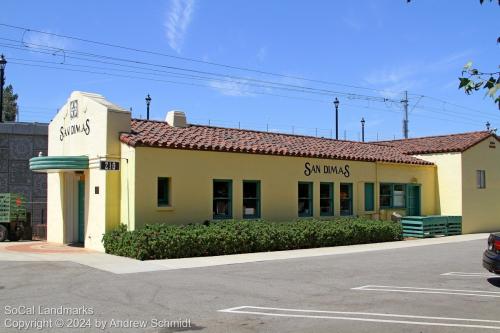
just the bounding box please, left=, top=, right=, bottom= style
left=30, top=156, right=89, bottom=172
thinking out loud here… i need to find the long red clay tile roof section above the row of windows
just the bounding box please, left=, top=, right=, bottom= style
left=120, top=119, right=432, bottom=165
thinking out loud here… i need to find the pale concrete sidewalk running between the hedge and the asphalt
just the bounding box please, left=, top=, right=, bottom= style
left=0, top=233, right=489, bottom=274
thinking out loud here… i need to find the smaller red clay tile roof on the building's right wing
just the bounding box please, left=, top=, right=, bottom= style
left=372, top=131, right=496, bottom=155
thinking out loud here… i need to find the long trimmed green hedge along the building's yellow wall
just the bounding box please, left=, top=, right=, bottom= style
left=103, top=218, right=402, bottom=260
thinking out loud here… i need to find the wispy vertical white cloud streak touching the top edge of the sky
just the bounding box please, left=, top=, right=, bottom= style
left=164, top=0, right=194, bottom=53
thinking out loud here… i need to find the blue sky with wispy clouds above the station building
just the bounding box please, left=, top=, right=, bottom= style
left=0, top=0, right=500, bottom=140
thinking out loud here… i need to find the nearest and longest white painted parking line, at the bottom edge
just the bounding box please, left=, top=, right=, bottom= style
left=219, top=306, right=500, bottom=330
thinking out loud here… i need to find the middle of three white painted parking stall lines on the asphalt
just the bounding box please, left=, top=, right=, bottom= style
left=351, top=285, right=500, bottom=298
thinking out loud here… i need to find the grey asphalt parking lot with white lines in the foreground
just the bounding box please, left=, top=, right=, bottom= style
left=0, top=235, right=500, bottom=332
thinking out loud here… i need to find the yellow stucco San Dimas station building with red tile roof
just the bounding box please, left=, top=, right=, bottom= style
left=30, top=92, right=500, bottom=251
